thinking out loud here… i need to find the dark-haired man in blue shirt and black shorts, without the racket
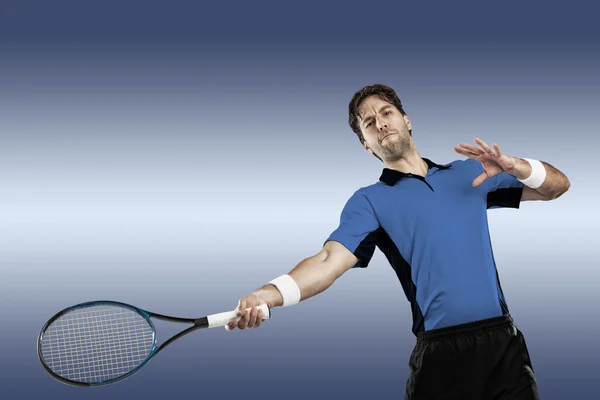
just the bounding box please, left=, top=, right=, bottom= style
left=226, top=85, right=570, bottom=400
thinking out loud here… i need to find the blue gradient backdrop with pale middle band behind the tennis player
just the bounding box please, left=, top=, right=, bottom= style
left=0, top=2, right=600, bottom=399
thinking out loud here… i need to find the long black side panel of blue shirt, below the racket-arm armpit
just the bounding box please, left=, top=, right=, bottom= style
left=374, top=227, right=425, bottom=335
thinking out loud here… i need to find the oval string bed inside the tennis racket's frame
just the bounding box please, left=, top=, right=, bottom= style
left=41, top=305, right=154, bottom=383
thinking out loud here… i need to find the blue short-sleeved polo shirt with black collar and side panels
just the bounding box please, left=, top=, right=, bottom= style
left=327, top=158, right=523, bottom=335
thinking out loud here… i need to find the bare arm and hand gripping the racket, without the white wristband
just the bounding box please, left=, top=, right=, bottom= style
left=228, top=241, right=358, bottom=329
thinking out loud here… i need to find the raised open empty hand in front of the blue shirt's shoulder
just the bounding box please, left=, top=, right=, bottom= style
left=454, top=138, right=516, bottom=186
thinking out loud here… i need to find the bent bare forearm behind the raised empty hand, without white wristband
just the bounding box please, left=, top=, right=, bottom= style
left=506, top=157, right=571, bottom=201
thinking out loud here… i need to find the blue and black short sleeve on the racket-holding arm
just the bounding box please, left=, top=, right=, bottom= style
left=325, top=189, right=379, bottom=268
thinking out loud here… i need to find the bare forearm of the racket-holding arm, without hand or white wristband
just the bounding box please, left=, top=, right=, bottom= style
left=254, top=253, right=339, bottom=307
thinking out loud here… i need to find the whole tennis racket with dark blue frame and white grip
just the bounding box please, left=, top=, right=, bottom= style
left=37, top=301, right=270, bottom=386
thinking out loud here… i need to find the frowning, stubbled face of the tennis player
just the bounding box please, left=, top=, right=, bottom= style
left=358, top=96, right=412, bottom=161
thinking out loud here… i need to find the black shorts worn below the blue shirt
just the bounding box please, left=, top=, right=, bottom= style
left=405, top=315, right=539, bottom=400
